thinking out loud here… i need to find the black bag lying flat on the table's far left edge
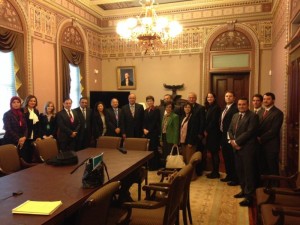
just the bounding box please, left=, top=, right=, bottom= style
left=46, top=151, right=78, bottom=166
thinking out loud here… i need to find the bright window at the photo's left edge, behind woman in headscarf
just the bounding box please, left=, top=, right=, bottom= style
left=0, top=51, right=17, bottom=133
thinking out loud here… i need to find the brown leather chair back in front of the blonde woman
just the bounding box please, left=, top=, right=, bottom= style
left=34, top=138, right=58, bottom=162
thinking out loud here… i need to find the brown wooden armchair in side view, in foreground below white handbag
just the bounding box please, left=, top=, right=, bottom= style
left=118, top=165, right=192, bottom=225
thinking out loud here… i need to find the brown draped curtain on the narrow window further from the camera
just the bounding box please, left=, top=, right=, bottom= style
left=61, top=47, right=85, bottom=99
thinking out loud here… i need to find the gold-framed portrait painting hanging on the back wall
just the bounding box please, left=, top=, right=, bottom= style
left=117, top=66, right=136, bottom=90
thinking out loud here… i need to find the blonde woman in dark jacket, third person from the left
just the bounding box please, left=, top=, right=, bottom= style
left=40, top=101, right=57, bottom=139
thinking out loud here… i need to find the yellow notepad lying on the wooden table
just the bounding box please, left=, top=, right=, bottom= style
left=12, top=200, right=62, bottom=215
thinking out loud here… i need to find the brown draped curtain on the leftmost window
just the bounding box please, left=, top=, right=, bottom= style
left=0, top=27, right=26, bottom=98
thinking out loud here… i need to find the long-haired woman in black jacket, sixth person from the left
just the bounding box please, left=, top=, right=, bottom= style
left=92, top=102, right=107, bottom=140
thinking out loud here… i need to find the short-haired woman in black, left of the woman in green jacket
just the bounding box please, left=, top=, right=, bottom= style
left=143, top=95, right=160, bottom=170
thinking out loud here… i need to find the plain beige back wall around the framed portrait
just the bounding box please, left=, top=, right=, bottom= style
left=102, top=55, right=201, bottom=104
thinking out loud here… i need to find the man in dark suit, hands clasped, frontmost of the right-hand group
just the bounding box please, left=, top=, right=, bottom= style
left=228, top=98, right=258, bottom=206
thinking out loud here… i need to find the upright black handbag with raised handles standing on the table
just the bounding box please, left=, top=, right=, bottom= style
left=82, top=159, right=109, bottom=188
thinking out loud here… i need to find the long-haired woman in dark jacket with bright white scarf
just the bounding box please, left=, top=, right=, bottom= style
left=22, top=95, right=41, bottom=163
